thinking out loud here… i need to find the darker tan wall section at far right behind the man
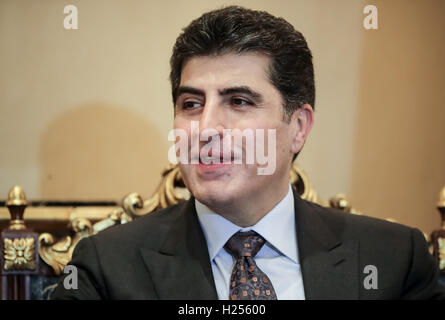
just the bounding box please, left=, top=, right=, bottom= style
left=350, top=0, right=445, bottom=232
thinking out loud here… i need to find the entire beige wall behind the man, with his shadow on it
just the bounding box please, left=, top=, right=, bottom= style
left=0, top=0, right=445, bottom=232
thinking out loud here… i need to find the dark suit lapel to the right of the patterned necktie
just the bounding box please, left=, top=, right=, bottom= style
left=294, top=192, right=359, bottom=299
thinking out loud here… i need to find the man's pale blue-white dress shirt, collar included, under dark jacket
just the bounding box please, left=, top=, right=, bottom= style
left=195, top=185, right=305, bottom=300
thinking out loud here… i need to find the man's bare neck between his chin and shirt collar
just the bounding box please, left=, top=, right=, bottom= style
left=207, top=183, right=289, bottom=228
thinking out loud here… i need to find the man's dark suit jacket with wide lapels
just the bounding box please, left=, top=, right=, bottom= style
left=52, top=192, right=445, bottom=299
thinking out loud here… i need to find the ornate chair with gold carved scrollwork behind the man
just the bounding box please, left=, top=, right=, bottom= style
left=0, top=163, right=445, bottom=299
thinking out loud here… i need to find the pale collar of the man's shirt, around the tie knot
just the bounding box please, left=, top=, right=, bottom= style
left=195, top=185, right=299, bottom=263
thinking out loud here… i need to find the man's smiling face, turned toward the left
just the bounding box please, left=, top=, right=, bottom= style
left=174, top=53, right=302, bottom=208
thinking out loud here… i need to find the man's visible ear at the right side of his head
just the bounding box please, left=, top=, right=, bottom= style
left=291, top=104, right=314, bottom=153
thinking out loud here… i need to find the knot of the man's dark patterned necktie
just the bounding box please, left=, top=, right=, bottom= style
left=224, top=230, right=265, bottom=259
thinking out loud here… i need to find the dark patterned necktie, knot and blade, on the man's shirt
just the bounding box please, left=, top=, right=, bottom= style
left=224, top=231, right=277, bottom=300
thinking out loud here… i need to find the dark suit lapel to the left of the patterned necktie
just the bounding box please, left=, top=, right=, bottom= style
left=137, top=198, right=218, bottom=300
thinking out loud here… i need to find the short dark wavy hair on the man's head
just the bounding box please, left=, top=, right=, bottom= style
left=170, top=6, right=315, bottom=119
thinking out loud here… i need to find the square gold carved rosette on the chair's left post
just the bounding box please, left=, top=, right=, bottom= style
left=4, top=237, right=36, bottom=270
